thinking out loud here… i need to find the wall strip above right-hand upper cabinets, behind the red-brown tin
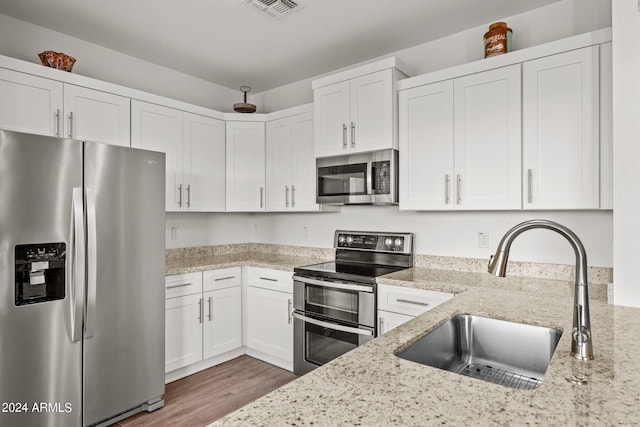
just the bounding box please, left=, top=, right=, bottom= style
left=252, top=0, right=611, bottom=111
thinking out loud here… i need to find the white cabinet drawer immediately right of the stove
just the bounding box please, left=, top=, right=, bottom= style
left=378, top=285, right=453, bottom=316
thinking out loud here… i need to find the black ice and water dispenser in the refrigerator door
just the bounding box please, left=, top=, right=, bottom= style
left=15, top=243, right=66, bottom=306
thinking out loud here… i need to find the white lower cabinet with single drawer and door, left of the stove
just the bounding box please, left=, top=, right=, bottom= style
left=245, top=267, right=293, bottom=371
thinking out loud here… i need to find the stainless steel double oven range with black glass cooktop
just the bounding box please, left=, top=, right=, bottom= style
left=293, top=231, right=413, bottom=375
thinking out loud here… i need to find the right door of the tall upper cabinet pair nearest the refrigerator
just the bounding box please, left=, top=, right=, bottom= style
left=183, top=113, right=226, bottom=212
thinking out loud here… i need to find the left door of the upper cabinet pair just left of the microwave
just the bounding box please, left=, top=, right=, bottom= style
left=266, top=117, right=292, bottom=211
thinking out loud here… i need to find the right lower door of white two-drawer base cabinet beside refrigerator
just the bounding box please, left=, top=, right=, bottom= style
left=202, top=286, right=242, bottom=359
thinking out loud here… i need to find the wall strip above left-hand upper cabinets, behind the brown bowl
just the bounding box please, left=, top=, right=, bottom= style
left=0, top=14, right=242, bottom=111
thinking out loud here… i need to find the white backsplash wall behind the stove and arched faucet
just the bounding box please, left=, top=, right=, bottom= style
left=249, top=206, right=612, bottom=267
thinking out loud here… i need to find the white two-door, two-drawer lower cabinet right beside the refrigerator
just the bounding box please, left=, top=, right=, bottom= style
left=165, top=267, right=242, bottom=381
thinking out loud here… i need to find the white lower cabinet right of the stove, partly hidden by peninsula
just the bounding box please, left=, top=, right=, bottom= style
left=378, top=285, right=453, bottom=335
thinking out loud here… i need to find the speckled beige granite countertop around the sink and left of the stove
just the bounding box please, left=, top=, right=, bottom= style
left=167, top=251, right=640, bottom=426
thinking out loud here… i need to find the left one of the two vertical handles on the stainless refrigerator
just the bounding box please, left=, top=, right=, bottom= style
left=69, top=187, right=85, bottom=341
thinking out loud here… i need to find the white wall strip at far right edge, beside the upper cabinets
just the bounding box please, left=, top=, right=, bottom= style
left=612, top=0, right=640, bottom=307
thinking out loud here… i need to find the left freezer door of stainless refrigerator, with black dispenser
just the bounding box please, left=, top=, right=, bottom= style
left=0, top=130, right=84, bottom=427
